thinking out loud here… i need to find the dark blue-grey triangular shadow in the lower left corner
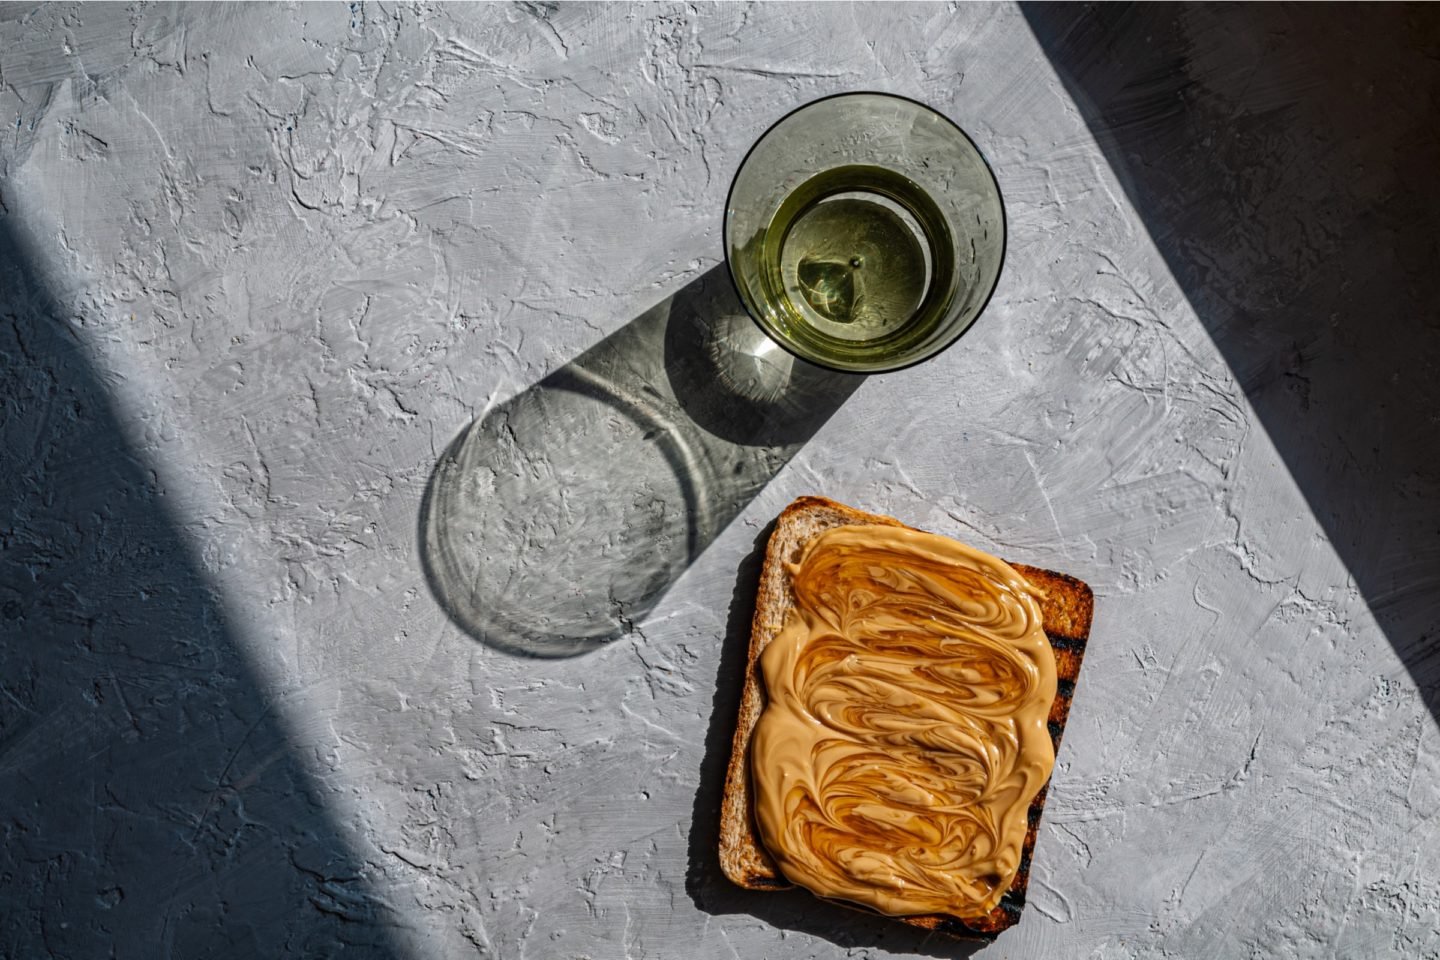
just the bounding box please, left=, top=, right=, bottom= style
left=0, top=219, right=397, bottom=960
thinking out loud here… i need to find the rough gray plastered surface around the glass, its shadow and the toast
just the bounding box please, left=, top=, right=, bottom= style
left=0, top=3, right=1440, bottom=960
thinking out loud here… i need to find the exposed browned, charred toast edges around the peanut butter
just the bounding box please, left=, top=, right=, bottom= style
left=720, top=497, right=1094, bottom=938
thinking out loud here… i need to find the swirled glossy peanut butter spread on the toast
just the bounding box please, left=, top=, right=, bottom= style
left=750, top=525, right=1056, bottom=918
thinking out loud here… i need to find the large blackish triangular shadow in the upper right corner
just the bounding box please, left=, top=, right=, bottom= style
left=1024, top=4, right=1440, bottom=720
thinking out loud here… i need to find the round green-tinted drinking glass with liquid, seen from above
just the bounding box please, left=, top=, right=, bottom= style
left=724, top=94, right=1005, bottom=373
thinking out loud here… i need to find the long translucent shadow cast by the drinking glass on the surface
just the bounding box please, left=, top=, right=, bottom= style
left=419, top=265, right=861, bottom=658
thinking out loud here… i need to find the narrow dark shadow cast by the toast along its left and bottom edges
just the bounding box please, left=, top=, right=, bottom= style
left=685, top=522, right=989, bottom=959
